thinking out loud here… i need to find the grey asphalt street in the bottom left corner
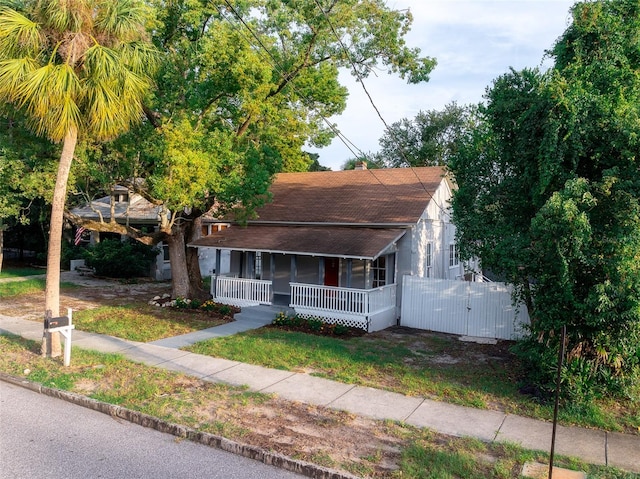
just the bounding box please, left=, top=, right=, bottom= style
left=0, top=381, right=302, bottom=479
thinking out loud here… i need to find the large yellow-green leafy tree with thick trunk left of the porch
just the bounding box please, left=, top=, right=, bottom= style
left=77, top=0, right=434, bottom=298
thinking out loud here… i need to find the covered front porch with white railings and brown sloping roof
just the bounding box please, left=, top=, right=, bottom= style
left=199, top=227, right=404, bottom=332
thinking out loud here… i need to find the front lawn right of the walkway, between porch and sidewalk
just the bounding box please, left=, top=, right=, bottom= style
left=185, top=328, right=640, bottom=434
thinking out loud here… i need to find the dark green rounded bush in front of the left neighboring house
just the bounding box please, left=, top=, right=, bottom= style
left=84, top=240, right=158, bottom=278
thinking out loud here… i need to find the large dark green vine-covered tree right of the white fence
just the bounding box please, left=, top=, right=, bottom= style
left=450, top=0, right=640, bottom=401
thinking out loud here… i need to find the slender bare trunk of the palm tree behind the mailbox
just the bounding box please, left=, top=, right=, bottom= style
left=42, top=129, right=78, bottom=358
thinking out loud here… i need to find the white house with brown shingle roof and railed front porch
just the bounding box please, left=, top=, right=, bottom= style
left=190, top=165, right=472, bottom=331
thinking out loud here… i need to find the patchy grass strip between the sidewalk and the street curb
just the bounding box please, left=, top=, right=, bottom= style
left=0, top=335, right=640, bottom=479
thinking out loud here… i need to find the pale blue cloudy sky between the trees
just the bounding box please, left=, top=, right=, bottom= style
left=309, top=0, right=574, bottom=170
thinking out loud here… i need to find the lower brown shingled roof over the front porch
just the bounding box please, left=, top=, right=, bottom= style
left=189, top=226, right=405, bottom=260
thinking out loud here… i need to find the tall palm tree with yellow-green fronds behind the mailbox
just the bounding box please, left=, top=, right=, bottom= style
left=0, top=0, right=157, bottom=357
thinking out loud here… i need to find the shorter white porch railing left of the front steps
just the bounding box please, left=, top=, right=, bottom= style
left=211, top=276, right=273, bottom=306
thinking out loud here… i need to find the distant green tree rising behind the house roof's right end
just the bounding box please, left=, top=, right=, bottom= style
left=375, top=102, right=476, bottom=168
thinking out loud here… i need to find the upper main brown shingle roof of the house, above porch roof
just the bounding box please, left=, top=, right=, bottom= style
left=253, top=167, right=444, bottom=224
